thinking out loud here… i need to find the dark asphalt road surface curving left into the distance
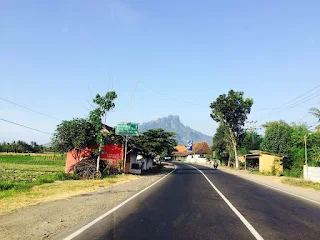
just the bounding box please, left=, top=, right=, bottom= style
left=63, top=163, right=320, bottom=240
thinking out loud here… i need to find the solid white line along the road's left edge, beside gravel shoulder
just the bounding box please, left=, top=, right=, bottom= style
left=64, top=165, right=177, bottom=240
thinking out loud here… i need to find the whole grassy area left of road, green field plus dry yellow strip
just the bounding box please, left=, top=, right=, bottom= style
left=0, top=154, right=139, bottom=214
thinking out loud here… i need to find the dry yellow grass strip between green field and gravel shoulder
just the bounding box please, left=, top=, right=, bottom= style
left=0, top=175, right=140, bottom=214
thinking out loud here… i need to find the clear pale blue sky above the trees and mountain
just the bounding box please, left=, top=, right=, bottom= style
left=0, top=0, right=320, bottom=143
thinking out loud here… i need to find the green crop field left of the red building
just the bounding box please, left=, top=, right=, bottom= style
left=0, top=155, right=73, bottom=198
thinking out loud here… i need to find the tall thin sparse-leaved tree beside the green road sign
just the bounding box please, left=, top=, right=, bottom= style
left=89, top=91, right=117, bottom=173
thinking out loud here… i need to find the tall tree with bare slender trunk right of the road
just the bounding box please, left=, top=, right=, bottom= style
left=210, top=90, right=253, bottom=168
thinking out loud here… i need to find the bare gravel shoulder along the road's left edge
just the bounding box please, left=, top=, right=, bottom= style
left=0, top=165, right=174, bottom=240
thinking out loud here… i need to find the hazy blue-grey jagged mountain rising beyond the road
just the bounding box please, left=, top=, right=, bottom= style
left=139, top=115, right=212, bottom=146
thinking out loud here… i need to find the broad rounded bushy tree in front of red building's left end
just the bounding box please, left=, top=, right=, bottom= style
left=52, top=118, right=96, bottom=159
